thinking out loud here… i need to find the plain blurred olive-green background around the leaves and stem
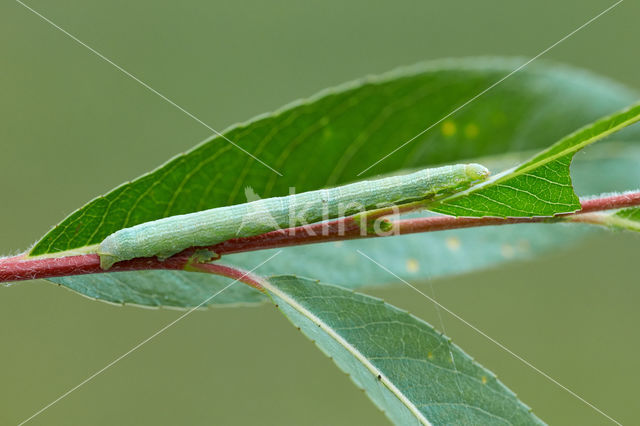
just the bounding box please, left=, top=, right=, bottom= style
left=0, top=0, right=640, bottom=425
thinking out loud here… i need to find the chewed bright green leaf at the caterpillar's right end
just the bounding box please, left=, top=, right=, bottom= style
left=432, top=104, right=640, bottom=217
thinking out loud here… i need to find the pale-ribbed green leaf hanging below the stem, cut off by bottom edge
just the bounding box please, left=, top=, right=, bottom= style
left=264, top=276, right=543, bottom=425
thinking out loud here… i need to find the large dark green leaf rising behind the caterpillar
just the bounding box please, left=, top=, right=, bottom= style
left=30, top=58, right=634, bottom=256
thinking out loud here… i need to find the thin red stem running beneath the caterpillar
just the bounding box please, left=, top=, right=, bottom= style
left=0, top=192, right=640, bottom=282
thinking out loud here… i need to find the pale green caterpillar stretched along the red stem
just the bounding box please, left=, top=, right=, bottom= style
left=98, top=164, right=489, bottom=270
